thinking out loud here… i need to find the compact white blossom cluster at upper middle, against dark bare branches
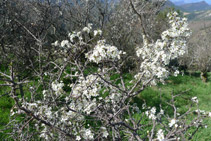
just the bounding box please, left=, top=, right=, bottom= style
left=86, top=40, right=125, bottom=64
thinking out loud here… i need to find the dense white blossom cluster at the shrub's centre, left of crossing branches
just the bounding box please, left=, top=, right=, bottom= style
left=65, top=75, right=101, bottom=116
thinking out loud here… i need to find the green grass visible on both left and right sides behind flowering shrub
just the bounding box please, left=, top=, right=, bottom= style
left=0, top=73, right=211, bottom=141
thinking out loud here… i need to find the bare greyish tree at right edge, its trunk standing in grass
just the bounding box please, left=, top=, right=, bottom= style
left=183, top=23, right=211, bottom=82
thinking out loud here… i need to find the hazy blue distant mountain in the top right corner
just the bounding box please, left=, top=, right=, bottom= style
left=180, top=1, right=211, bottom=12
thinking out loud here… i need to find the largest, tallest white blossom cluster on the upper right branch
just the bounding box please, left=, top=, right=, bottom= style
left=135, top=12, right=190, bottom=84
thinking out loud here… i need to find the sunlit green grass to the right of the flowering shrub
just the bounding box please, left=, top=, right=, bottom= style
left=139, top=73, right=211, bottom=141
